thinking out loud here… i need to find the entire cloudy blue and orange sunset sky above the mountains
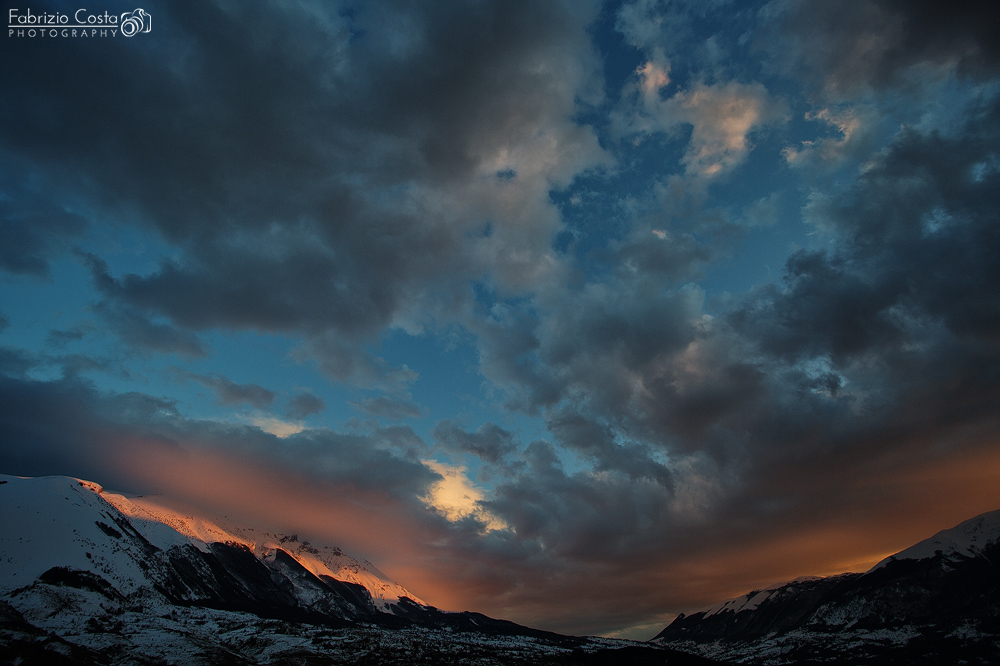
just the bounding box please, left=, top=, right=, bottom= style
left=0, top=0, right=1000, bottom=639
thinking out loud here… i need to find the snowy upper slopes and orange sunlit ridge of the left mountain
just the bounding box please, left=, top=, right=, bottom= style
left=0, top=475, right=427, bottom=612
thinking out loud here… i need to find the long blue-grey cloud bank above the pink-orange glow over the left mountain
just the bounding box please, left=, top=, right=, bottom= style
left=0, top=376, right=436, bottom=506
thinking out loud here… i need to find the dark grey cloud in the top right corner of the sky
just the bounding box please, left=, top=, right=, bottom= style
left=761, top=0, right=1000, bottom=98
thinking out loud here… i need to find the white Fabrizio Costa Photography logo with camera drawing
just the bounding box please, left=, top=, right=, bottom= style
left=7, top=8, right=153, bottom=38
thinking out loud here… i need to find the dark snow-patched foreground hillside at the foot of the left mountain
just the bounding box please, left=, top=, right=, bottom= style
left=0, top=586, right=718, bottom=666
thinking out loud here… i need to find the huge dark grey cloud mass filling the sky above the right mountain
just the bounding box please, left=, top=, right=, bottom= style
left=444, top=92, right=1000, bottom=628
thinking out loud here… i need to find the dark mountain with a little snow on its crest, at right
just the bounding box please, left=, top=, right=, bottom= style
left=653, top=511, right=1000, bottom=664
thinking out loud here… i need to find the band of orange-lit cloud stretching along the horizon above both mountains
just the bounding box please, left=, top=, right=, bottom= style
left=1, top=368, right=1000, bottom=637
